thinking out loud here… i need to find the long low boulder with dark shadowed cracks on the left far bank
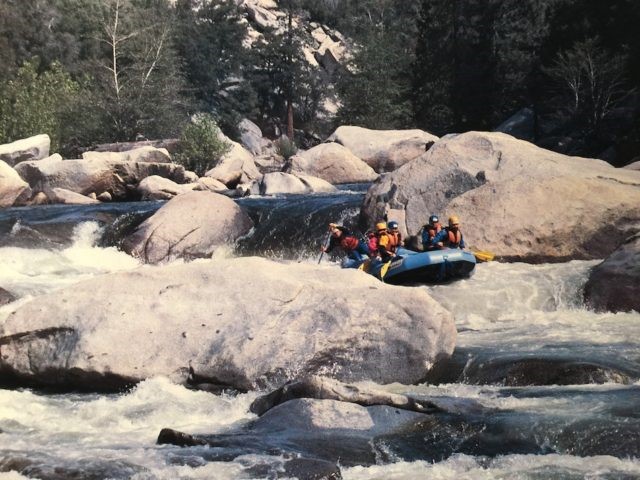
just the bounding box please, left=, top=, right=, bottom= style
left=16, top=157, right=185, bottom=200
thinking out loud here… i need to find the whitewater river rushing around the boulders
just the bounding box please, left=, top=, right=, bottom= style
left=0, top=189, right=640, bottom=480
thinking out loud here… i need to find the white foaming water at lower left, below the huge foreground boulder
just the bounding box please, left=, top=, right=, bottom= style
left=0, top=378, right=256, bottom=465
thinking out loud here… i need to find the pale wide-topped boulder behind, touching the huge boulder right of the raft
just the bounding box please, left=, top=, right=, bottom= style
left=327, top=126, right=438, bottom=173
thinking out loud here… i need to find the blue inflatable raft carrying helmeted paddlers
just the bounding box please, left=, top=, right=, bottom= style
left=369, top=248, right=476, bottom=285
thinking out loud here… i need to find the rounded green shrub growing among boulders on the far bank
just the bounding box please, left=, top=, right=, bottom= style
left=175, top=113, right=231, bottom=176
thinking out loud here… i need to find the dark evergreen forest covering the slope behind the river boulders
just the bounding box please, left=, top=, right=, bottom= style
left=0, top=0, right=640, bottom=166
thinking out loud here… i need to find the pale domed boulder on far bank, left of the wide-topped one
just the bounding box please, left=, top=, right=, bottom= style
left=290, top=143, right=378, bottom=185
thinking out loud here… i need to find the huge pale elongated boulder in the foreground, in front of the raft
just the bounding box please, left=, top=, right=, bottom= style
left=0, top=256, right=456, bottom=390
